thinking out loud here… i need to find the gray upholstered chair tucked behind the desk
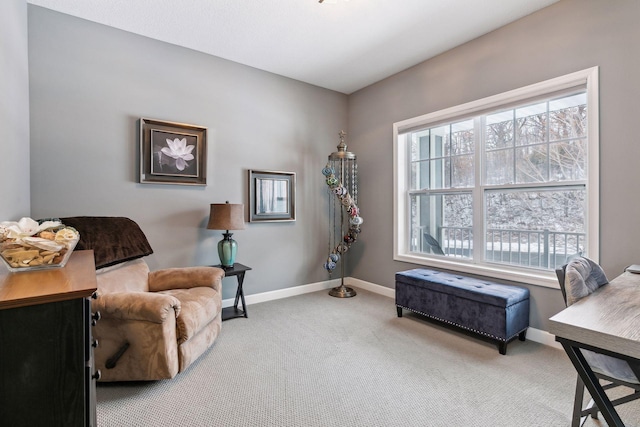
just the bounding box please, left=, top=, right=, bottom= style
left=556, top=257, right=640, bottom=427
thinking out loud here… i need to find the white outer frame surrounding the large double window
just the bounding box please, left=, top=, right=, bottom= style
left=393, top=67, right=600, bottom=288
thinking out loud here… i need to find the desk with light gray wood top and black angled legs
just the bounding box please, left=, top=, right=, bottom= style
left=549, top=273, right=640, bottom=427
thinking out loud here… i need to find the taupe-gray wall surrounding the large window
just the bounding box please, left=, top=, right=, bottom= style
left=349, top=0, right=640, bottom=330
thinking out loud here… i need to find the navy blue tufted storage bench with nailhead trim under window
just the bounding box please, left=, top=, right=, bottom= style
left=396, top=268, right=529, bottom=354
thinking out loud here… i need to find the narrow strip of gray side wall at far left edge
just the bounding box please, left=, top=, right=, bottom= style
left=0, top=0, right=30, bottom=221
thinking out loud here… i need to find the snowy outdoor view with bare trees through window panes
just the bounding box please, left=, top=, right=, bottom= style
left=409, top=91, right=588, bottom=269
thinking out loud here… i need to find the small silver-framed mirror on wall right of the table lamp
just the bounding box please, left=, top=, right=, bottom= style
left=249, top=169, right=296, bottom=222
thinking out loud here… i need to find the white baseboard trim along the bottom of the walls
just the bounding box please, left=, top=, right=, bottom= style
left=222, top=277, right=562, bottom=350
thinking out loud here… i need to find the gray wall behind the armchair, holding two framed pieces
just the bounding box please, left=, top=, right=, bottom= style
left=28, top=5, right=347, bottom=298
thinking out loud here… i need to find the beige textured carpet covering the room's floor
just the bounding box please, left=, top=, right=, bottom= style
left=97, top=290, right=640, bottom=427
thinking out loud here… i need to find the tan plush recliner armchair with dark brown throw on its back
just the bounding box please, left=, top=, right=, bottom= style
left=61, top=217, right=224, bottom=381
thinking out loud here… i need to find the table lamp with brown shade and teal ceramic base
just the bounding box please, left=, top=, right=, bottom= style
left=207, top=201, right=244, bottom=268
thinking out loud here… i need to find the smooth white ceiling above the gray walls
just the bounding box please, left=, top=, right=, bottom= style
left=27, top=0, right=558, bottom=94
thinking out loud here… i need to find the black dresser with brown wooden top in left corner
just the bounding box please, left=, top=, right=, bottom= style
left=0, top=251, right=100, bottom=427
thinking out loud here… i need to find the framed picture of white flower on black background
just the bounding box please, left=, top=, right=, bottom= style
left=140, top=118, right=207, bottom=185
